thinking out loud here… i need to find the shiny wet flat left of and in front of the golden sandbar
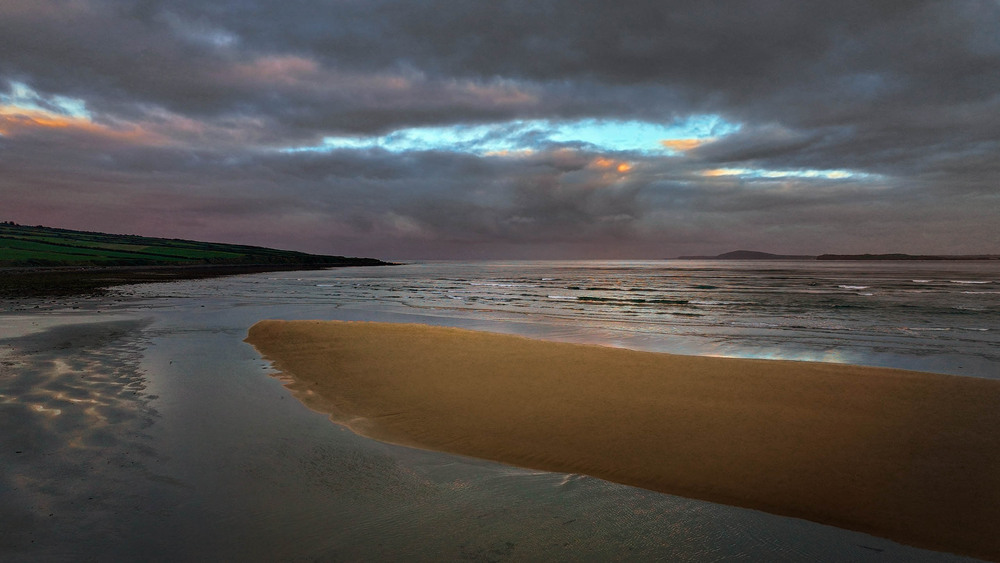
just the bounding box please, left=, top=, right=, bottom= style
left=0, top=292, right=984, bottom=561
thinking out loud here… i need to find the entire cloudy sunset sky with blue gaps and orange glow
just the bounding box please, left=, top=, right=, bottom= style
left=0, top=0, right=1000, bottom=260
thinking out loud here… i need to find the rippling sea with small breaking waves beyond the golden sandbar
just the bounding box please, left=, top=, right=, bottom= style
left=127, top=261, right=1000, bottom=377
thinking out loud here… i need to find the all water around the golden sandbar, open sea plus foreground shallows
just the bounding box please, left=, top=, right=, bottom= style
left=0, top=261, right=1000, bottom=562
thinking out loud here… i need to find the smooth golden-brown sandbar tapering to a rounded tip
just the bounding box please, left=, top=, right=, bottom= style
left=247, top=321, right=1000, bottom=559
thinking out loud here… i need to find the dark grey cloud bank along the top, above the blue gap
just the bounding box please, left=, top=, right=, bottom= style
left=7, top=0, right=1000, bottom=134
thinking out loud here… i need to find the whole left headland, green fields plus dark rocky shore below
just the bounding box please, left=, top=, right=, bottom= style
left=0, top=221, right=391, bottom=298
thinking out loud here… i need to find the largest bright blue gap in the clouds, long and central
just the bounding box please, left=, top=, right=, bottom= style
left=284, top=114, right=740, bottom=154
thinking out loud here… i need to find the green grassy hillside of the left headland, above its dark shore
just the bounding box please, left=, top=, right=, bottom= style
left=0, top=223, right=382, bottom=267
